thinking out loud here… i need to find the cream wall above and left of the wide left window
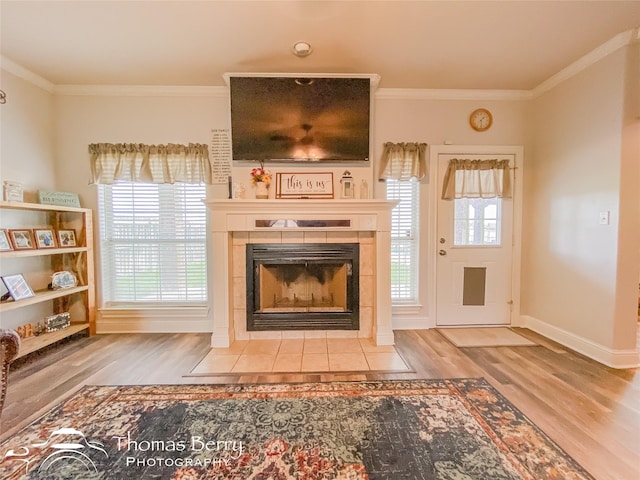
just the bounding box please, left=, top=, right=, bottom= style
left=55, top=94, right=228, bottom=209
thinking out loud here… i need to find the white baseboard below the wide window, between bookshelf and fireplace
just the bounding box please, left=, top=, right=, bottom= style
left=96, top=307, right=213, bottom=333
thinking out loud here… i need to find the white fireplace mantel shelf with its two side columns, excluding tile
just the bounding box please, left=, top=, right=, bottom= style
left=205, top=199, right=397, bottom=347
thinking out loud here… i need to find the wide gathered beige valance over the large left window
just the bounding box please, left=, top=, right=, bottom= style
left=89, top=143, right=212, bottom=184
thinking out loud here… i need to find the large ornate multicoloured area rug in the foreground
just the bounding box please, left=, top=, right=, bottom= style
left=0, top=378, right=593, bottom=480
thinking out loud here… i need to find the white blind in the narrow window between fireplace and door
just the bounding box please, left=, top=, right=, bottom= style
left=386, top=180, right=420, bottom=304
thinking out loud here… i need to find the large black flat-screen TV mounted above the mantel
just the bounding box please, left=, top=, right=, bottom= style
left=229, top=76, right=371, bottom=162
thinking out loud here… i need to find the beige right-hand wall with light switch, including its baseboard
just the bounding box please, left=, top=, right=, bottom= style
left=522, top=48, right=638, bottom=364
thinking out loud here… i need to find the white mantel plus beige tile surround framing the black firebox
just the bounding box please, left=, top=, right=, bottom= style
left=207, top=199, right=396, bottom=347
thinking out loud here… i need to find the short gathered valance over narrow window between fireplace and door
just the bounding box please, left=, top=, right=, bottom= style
left=379, top=142, right=427, bottom=181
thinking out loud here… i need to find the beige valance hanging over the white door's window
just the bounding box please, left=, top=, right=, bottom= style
left=442, top=158, right=511, bottom=200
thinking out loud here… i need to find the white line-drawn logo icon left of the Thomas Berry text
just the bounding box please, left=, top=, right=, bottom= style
left=3, top=428, right=109, bottom=478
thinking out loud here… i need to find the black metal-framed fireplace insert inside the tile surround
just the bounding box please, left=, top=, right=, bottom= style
left=246, top=243, right=360, bottom=331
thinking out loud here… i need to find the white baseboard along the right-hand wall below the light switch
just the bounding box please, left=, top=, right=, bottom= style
left=519, top=315, right=640, bottom=368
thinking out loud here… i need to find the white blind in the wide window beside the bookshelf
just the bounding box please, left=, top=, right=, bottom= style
left=98, top=182, right=207, bottom=306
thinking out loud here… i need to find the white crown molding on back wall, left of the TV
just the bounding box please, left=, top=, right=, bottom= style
left=53, top=85, right=228, bottom=97
